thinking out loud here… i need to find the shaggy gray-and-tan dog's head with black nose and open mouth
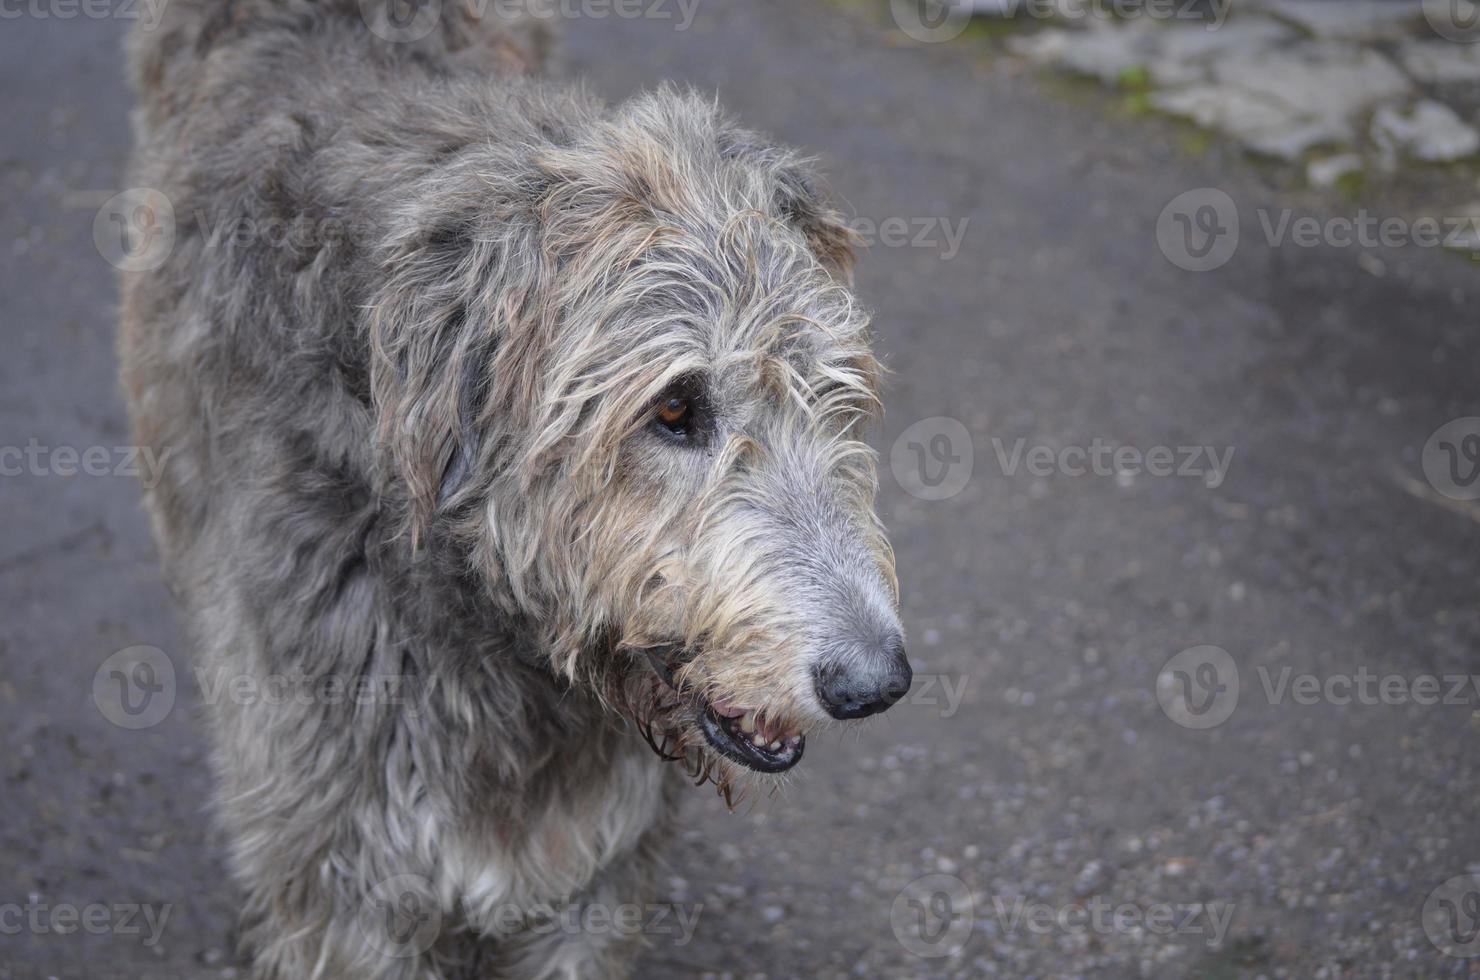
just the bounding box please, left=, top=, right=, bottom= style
left=373, top=90, right=910, bottom=805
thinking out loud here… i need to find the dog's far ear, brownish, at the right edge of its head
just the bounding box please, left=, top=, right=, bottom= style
left=719, top=129, right=863, bottom=283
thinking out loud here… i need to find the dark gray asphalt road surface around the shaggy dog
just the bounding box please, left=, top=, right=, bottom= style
left=0, top=0, right=1480, bottom=980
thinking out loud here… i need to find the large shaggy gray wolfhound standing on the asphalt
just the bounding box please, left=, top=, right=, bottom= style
left=121, top=0, right=910, bottom=980
